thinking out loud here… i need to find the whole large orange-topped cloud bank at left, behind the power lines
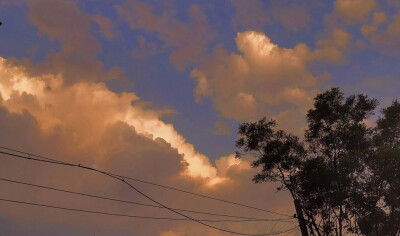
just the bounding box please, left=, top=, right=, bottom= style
left=0, top=55, right=292, bottom=235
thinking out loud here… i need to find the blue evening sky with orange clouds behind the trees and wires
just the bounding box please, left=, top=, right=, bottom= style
left=0, top=0, right=400, bottom=236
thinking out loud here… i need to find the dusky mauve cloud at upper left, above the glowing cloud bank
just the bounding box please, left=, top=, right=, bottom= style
left=23, top=0, right=123, bottom=84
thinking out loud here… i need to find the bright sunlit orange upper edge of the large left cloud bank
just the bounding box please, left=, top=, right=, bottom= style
left=0, top=59, right=216, bottom=181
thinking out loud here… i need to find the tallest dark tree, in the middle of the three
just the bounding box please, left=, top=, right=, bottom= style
left=299, top=88, right=377, bottom=236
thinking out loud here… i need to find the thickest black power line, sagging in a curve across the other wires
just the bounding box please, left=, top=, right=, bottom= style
left=0, top=148, right=296, bottom=236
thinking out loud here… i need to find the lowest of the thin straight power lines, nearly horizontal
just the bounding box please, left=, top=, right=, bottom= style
left=0, top=198, right=286, bottom=222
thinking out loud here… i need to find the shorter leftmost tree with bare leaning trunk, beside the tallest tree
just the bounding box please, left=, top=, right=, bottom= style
left=236, top=118, right=308, bottom=235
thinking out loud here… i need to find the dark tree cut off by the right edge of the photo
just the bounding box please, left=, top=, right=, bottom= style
left=359, top=101, right=400, bottom=235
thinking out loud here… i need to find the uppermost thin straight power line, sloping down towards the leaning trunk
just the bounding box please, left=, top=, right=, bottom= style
left=0, top=146, right=293, bottom=218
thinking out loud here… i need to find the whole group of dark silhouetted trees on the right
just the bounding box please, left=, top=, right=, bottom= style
left=236, top=88, right=400, bottom=235
